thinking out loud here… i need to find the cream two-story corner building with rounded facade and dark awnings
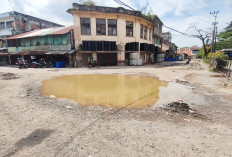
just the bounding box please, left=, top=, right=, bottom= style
left=67, top=3, right=163, bottom=66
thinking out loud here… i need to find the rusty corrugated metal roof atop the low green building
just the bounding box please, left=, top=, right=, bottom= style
left=7, top=26, right=74, bottom=40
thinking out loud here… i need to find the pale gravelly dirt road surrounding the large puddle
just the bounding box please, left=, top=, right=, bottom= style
left=0, top=60, right=232, bottom=157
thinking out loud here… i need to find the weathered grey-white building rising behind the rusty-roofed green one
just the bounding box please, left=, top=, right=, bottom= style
left=0, top=11, right=62, bottom=48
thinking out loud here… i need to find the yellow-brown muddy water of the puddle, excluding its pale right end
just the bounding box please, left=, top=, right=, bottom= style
left=40, top=75, right=168, bottom=108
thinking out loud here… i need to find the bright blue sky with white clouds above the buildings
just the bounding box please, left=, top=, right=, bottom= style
left=0, top=0, right=232, bottom=47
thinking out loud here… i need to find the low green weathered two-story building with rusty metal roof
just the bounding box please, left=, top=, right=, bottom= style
left=7, top=26, right=75, bottom=67
